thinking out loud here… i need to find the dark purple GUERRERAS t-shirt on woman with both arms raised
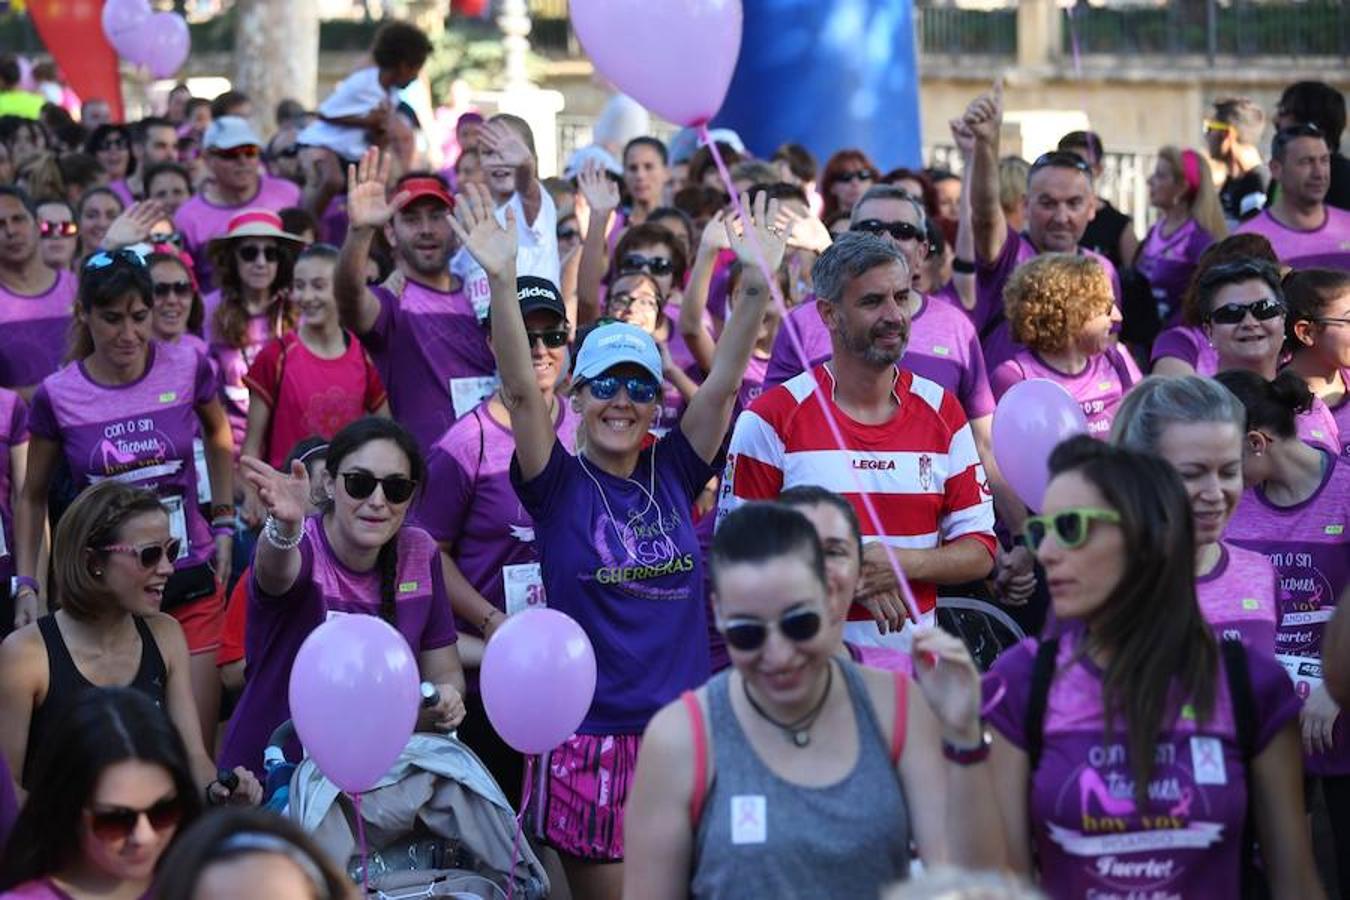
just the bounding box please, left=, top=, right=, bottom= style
left=510, top=428, right=721, bottom=734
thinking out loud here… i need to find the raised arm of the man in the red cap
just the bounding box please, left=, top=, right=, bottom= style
left=333, top=147, right=402, bottom=335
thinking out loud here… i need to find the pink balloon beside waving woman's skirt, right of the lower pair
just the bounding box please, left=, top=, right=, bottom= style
left=478, top=609, right=595, bottom=753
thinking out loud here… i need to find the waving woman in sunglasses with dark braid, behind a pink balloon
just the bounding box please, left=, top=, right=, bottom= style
left=221, top=417, right=464, bottom=772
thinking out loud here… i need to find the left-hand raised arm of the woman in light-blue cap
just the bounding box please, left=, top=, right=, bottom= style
left=451, top=178, right=558, bottom=480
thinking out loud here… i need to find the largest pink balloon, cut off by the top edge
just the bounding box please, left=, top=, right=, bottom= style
left=571, top=0, right=743, bottom=125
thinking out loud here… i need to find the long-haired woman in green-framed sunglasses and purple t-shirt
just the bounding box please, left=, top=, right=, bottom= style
left=990, top=436, right=1323, bottom=899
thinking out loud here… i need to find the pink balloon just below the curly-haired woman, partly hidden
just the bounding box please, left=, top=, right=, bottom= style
left=994, top=378, right=1088, bottom=511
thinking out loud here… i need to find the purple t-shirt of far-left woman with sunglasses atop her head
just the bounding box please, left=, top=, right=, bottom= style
left=28, top=343, right=216, bottom=569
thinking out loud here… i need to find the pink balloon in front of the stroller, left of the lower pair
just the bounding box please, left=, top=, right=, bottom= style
left=290, top=614, right=421, bottom=793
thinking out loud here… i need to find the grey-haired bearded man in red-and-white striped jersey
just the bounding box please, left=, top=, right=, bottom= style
left=720, top=232, right=996, bottom=646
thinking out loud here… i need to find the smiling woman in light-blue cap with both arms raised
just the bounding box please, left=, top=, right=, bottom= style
left=455, top=185, right=784, bottom=897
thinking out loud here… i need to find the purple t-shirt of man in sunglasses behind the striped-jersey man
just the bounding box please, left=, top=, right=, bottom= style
left=764, top=297, right=994, bottom=420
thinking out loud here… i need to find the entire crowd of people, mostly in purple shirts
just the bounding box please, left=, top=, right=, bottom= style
left=0, top=23, right=1350, bottom=900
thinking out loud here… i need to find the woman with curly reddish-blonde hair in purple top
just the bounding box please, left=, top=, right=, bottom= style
left=990, top=254, right=1142, bottom=437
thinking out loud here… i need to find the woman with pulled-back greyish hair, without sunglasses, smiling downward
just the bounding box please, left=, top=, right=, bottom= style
left=1111, top=375, right=1280, bottom=656
